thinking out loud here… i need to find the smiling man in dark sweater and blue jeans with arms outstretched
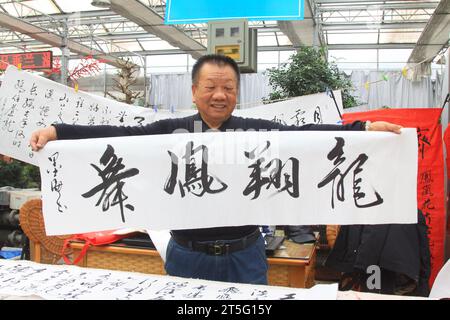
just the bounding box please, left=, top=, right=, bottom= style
left=30, top=55, right=401, bottom=284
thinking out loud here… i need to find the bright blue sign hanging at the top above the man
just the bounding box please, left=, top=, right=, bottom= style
left=165, top=0, right=304, bottom=24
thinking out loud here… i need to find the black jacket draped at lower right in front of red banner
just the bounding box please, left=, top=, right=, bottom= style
left=325, top=211, right=430, bottom=296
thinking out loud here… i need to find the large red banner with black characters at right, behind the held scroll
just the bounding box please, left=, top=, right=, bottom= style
left=343, top=108, right=445, bottom=287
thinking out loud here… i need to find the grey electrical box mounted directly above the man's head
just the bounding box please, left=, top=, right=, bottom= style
left=208, top=20, right=258, bottom=73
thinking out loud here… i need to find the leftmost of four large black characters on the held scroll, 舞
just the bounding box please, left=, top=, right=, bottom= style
left=82, top=145, right=139, bottom=222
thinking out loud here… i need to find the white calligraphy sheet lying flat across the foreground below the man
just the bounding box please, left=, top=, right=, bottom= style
left=0, top=260, right=338, bottom=302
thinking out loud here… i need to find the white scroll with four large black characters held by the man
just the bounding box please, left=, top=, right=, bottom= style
left=39, top=129, right=417, bottom=235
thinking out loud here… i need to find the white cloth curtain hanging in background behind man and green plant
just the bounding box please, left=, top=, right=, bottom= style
left=148, top=71, right=442, bottom=110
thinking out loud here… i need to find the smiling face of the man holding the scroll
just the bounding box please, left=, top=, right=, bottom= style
left=192, top=63, right=238, bottom=128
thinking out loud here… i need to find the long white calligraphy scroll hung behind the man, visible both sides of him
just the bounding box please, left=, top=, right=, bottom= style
left=0, top=66, right=342, bottom=165
